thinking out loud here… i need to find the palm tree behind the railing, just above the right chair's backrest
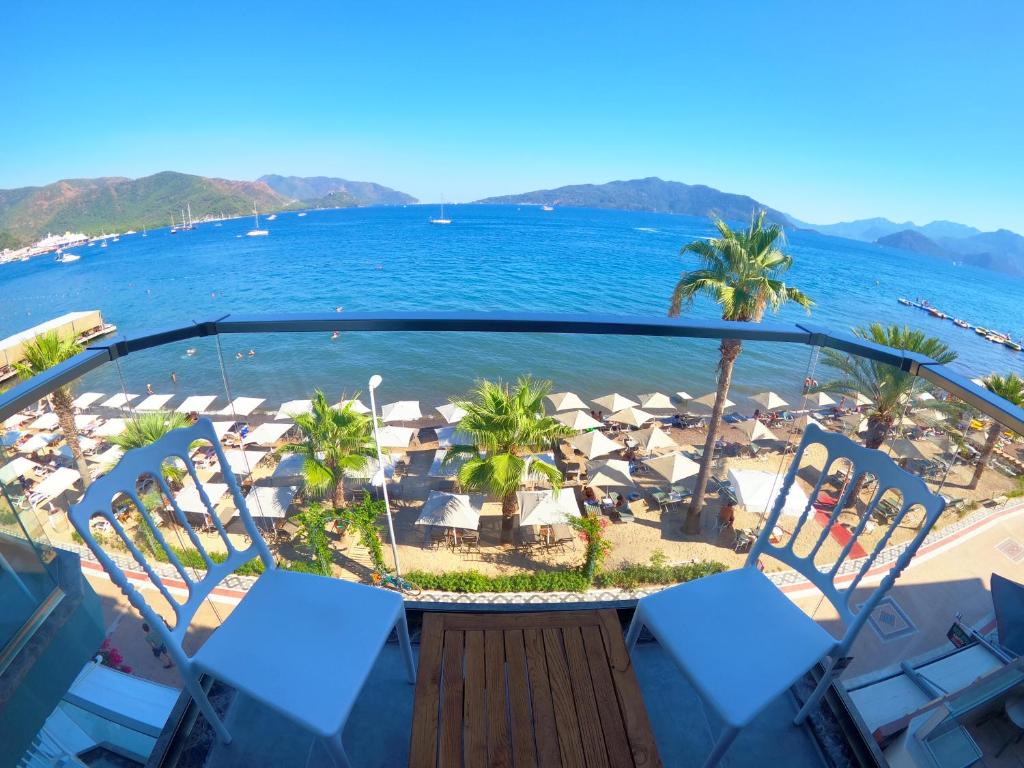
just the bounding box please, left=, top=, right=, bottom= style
left=815, top=323, right=961, bottom=450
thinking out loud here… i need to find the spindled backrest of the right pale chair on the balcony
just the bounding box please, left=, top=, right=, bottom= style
left=746, top=424, right=945, bottom=651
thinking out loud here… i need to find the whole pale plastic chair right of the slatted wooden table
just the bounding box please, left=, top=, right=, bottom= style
left=626, top=424, right=944, bottom=768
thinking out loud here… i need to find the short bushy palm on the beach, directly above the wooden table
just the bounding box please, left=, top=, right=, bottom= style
left=444, top=376, right=574, bottom=544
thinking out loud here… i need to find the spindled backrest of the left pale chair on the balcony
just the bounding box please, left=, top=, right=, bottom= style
left=68, top=418, right=274, bottom=660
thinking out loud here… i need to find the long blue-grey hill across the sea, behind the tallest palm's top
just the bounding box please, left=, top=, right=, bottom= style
left=476, top=176, right=791, bottom=225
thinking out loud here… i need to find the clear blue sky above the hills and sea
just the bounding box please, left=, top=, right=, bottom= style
left=0, top=0, right=1024, bottom=231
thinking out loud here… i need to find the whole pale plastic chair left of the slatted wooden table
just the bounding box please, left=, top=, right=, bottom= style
left=69, top=419, right=416, bottom=767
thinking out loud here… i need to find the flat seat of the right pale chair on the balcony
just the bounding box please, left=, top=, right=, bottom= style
left=637, top=567, right=837, bottom=728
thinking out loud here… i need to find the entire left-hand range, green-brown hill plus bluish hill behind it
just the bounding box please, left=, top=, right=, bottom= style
left=0, top=171, right=416, bottom=250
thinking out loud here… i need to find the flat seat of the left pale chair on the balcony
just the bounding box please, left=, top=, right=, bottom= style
left=193, top=568, right=404, bottom=737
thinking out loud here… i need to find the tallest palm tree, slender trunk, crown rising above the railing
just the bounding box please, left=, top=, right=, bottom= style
left=669, top=210, right=814, bottom=534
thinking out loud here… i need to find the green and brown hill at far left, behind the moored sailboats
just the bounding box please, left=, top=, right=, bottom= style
left=0, top=171, right=296, bottom=247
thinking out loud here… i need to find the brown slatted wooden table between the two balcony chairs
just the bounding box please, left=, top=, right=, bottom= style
left=409, top=610, right=662, bottom=768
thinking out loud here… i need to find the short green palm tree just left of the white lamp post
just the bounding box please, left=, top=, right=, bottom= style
left=282, top=389, right=377, bottom=509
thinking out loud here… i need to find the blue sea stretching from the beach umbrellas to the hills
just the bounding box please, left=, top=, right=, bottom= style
left=0, top=205, right=1024, bottom=407
